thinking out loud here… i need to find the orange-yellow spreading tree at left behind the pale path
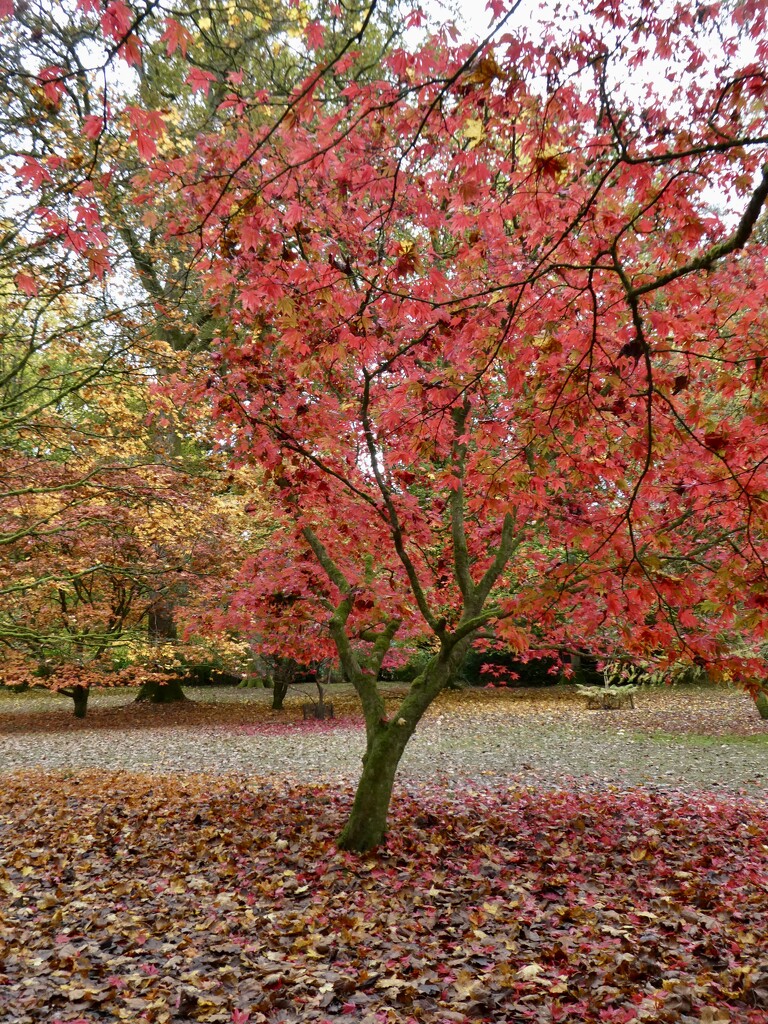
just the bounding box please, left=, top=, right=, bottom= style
left=0, top=344, right=262, bottom=717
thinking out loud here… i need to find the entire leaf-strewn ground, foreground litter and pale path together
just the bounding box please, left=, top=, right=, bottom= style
left=0, top=687, right=768, bottom=1024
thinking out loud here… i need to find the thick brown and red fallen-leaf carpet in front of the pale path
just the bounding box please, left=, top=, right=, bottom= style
left=0, top=772, right=768, bottom=1024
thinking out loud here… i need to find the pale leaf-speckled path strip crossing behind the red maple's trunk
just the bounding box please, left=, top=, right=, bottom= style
left=0, top=689, right=768, bottom=799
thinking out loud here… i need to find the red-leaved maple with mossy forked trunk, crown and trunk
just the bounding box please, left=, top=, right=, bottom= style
left=9, top=0, right=768, bottom=850
